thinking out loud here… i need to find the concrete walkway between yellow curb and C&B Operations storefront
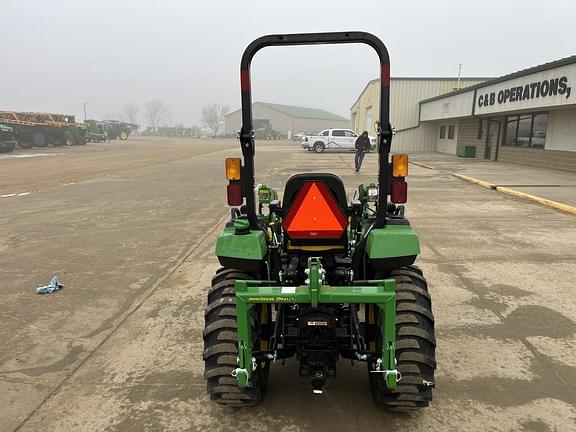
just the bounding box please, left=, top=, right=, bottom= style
left=410, top=153, right=576, bottom=211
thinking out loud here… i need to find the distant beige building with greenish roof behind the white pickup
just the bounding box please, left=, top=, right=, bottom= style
left=224, top=102, right=350, bottom=138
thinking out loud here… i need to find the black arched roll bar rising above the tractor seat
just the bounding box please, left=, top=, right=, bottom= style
left=240, top=32, right=392, bottom=229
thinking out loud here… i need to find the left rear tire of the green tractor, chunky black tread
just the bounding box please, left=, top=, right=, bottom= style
left=204, top=268, right=270, bottom=407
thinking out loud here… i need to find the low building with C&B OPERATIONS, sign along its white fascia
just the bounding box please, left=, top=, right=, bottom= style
left=416, top=56, right=576, bottom=171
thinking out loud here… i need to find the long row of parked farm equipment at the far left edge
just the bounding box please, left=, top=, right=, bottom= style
left=0, top=111, right=88, bottom=148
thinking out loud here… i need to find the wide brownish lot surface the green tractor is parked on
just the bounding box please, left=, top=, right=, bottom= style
left=0, top=139, right=576, bottom=432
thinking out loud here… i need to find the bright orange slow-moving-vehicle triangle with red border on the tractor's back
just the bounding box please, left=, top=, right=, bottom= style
left=284, top=182, right=348, bottom=239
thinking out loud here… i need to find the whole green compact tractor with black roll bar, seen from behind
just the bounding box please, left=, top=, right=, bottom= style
left=203, top=32, right=436, bottom=410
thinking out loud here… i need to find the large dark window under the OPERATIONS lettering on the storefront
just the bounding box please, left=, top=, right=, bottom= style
left=504, top=113, right=548, bottom=148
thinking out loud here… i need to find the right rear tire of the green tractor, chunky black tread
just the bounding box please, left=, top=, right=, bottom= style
left=368, top=266, right=436, bottom=411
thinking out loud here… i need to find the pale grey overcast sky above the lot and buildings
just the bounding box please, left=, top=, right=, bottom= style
left=0, top=0, right=576, bottom=126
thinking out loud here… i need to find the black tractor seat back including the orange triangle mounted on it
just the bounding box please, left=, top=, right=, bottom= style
left=282, top=173, right=348, bottom=252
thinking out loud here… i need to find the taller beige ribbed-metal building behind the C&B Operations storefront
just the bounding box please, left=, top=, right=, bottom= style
left=351, top=78, right=490, bottom=152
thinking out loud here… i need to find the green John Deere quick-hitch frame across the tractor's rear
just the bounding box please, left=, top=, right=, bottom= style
left=232, top=257, right=400, bottom=390
